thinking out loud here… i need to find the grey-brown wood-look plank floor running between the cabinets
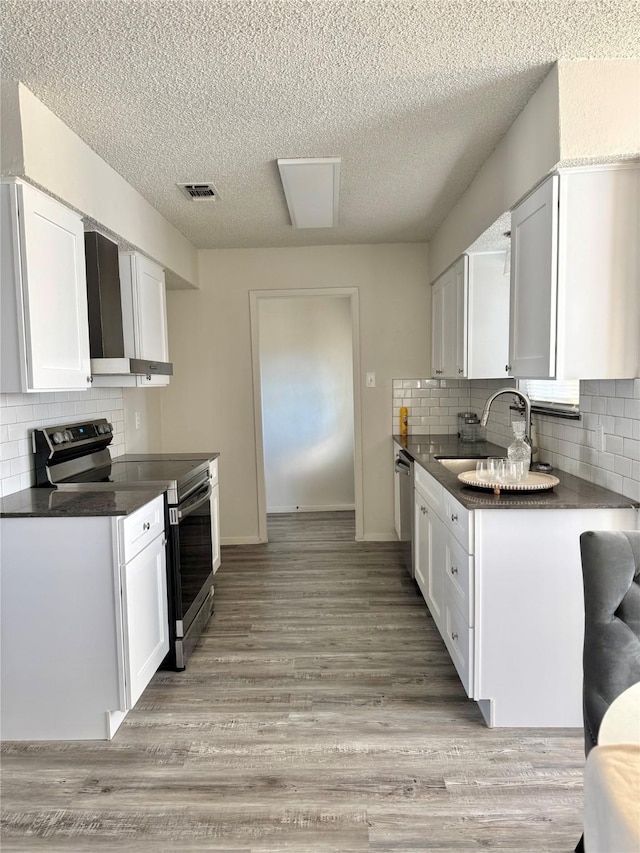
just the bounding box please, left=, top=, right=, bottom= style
left=2, top=513, right=584, bottom=853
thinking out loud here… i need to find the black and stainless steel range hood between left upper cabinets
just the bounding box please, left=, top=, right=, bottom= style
left=84, top=231, right=173, bottom=376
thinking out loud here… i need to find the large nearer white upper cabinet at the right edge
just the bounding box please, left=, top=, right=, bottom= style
left=507, top=166, right=640, bottom=379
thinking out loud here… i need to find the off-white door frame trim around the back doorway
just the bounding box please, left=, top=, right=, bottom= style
left=249, top=287, right=364, bottom=542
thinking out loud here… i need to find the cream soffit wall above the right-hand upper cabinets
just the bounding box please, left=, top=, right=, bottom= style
left=429, top=60, right=640, bottom=281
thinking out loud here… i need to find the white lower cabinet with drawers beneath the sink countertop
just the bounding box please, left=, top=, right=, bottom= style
left=414, top=465, right=638, bottom=727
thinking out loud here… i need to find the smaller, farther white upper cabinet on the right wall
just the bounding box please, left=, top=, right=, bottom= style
left=431, top=252, right=509, bottom=379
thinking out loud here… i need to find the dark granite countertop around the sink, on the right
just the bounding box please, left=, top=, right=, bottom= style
left=393, top=435, right=640, bottom=509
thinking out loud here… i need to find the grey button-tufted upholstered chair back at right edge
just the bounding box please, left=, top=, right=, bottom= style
left=576, top=530, right=640, bottom=851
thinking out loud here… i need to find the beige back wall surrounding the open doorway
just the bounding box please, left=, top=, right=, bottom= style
left=162, top=244, right=431, bottom=542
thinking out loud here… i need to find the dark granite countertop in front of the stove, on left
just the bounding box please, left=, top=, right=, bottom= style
left=0, top=488, right=164, bottom=518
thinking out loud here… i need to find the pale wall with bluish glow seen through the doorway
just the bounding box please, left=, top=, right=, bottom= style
left=257, top=296, right=355, bottom=512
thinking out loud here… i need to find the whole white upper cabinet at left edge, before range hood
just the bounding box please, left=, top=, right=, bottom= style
left=0, top=180, right=91, bottom=392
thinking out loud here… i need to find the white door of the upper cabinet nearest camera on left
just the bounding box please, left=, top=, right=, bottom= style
left=3, top=183, right=91, bottom=391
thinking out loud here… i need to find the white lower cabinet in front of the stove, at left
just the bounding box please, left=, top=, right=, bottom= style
left=0, top=496, right=169, bottom=740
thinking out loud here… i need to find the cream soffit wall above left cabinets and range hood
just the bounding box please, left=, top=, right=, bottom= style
left=2, top=81, right=198, bottom=287
